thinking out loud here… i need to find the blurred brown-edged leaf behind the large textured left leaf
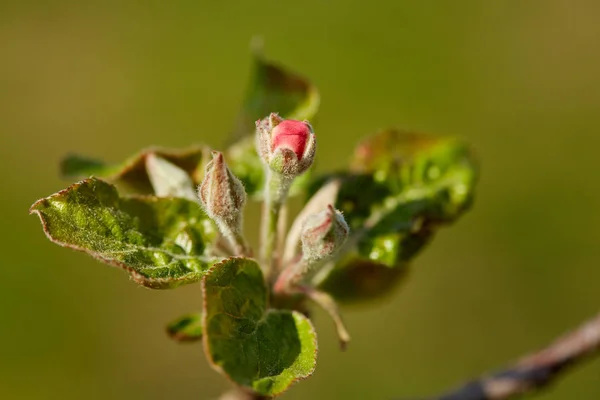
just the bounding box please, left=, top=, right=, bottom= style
left=60, top=146, right=210, bottom=198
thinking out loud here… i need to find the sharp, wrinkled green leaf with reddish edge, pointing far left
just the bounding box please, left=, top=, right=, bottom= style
left=29, top=178, right=218, bottom=289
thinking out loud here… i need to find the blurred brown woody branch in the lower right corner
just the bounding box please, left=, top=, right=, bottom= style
left=432, top=314, right=600, bottom=400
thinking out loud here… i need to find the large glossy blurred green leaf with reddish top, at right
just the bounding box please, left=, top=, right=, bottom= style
left=312, top=130, right=477, bottom=301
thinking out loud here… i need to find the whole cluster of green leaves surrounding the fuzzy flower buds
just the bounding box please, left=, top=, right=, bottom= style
left=30, top=45, right=477, bottom=396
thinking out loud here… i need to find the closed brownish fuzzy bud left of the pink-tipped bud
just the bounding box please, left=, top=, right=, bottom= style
left=198, top=151, right=246, bottom=233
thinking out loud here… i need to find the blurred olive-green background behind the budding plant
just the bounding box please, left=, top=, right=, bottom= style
left=0, top=0, right=600, bottom=400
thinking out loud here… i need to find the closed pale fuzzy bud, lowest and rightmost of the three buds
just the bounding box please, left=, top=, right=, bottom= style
left=301, top=204, right=350, bottom=264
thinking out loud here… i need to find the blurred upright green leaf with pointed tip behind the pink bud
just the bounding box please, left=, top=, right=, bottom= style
left=232, top=47, right=320, bottom=140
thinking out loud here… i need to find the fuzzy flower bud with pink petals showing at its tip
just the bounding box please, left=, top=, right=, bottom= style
left=256, top=113, right=316, bottom=177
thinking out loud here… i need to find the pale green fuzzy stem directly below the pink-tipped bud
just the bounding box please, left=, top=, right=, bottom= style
left=260, top=167, right=293, bottom=280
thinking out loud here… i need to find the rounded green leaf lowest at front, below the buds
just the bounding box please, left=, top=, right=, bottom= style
left=202, top=258, right=317, bottom=396
